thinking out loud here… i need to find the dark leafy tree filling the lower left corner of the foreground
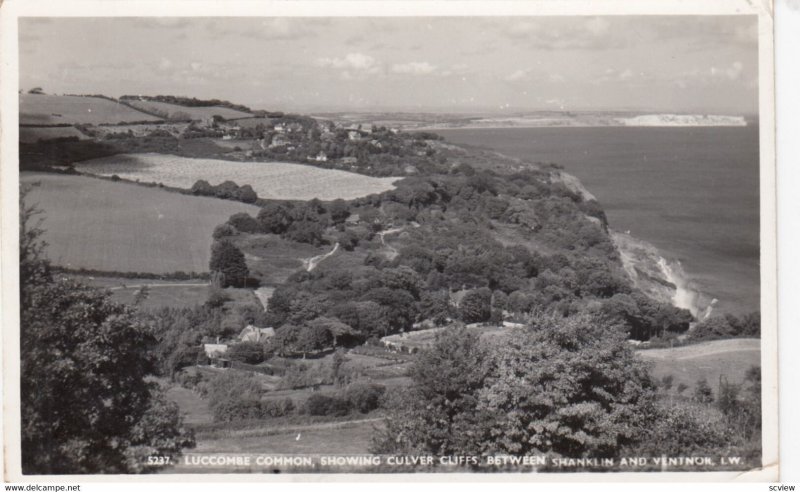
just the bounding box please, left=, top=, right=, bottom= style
left=20, top=191, right=194, bottom=474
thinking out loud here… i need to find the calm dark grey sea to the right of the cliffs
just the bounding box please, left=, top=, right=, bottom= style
left=438, top=126, right=760, bottom=312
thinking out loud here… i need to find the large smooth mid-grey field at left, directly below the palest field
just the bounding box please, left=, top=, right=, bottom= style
left=20, top=173, right=258, bottom=272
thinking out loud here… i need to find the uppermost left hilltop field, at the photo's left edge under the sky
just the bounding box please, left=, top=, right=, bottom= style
left=19, top=94, right=159, bottom=125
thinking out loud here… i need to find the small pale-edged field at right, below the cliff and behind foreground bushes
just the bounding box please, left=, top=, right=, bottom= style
left=637, top=338, right=761, bottom=393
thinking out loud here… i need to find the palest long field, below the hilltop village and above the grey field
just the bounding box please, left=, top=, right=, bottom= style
left=76, top=154, right=400, bottom=200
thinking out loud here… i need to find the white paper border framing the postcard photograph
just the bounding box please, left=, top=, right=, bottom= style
left=0, top=0, right=778, bottom=483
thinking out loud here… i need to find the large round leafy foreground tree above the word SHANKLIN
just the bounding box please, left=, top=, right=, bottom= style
left=480, top=313, right=654, bottom=458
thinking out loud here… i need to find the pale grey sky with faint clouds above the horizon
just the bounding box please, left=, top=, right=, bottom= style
left=19, top=15, right=758, bottom=114
